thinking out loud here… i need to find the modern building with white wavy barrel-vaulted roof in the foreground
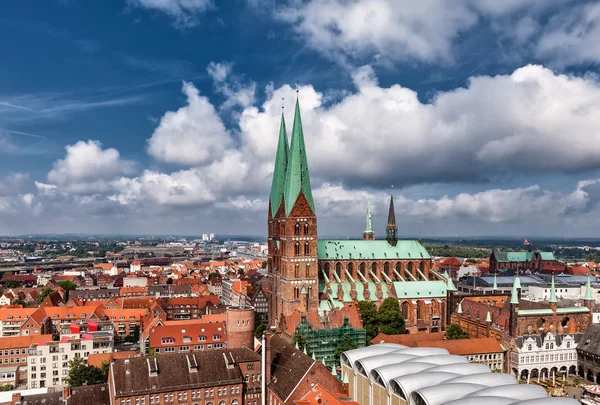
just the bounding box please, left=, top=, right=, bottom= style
left=340, top=343, right=578, bottom=405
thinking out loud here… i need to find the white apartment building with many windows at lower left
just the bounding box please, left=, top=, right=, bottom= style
left=27, top=332, right=113, bottom=389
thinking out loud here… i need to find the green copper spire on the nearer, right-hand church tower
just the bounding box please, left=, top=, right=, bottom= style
left=283, top=100, right=315, bottom=215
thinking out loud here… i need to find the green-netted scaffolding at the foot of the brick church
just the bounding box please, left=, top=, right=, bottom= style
left=295, top=315, right=367, bottom=368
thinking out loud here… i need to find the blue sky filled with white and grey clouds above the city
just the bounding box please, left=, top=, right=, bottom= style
left=0, top=0, right=600, bottom=237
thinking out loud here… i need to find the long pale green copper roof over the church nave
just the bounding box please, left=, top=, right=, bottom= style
left=316, top=238, right=431, bottom=260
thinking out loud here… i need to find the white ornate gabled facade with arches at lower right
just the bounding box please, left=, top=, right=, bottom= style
left=510, top=332, right=583, bottom=381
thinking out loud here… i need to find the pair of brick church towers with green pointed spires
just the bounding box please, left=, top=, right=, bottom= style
left=268, top=101, right=319, bottom=326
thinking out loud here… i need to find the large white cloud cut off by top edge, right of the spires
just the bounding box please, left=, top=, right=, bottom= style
left=276, top=0, right=572, bottom=63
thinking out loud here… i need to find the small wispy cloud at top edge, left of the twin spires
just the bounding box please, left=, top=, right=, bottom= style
left=127, top=0, right=214, bottom=28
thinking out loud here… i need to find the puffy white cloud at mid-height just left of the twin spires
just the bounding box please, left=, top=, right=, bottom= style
left=148, top=82, right=232, bottom=166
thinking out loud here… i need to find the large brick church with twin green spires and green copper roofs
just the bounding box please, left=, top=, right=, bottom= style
left=268, top=102, right=455, bottom=332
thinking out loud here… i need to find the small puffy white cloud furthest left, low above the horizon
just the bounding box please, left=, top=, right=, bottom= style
left=47, top=140, right=135, bottom=194
